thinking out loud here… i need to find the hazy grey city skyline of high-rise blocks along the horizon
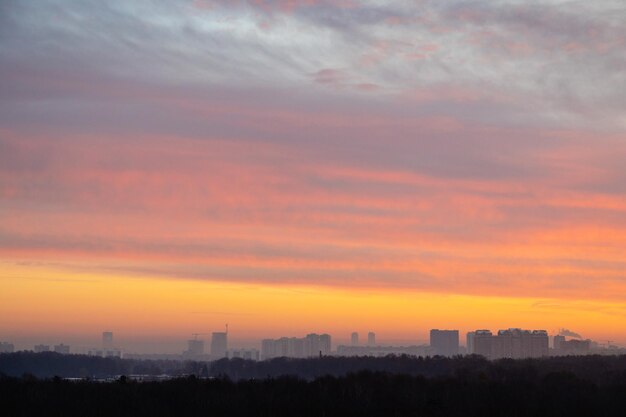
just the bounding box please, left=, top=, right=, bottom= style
left=0, top=327, right=626, bottom=360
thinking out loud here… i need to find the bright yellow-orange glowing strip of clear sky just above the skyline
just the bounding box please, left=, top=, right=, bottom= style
left=0, top=263, right=626, bottom=348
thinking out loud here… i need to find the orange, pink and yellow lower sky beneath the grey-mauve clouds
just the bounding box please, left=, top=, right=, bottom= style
left=0, top=132, right=626, bottom=351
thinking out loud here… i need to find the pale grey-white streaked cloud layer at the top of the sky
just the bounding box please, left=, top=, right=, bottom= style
left=0, top=0, right=626, bottom=130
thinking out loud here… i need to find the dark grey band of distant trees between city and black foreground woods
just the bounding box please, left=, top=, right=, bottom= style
left=0, top=352, right=626, bottom=383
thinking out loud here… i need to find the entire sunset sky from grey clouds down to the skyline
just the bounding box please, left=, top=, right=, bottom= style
left=0, top=0, right=626, bottom=352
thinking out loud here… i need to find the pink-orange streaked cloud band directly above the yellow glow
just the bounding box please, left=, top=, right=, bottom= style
left=0, top=127, right=626, bottom=299
